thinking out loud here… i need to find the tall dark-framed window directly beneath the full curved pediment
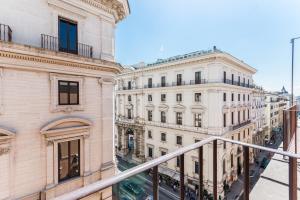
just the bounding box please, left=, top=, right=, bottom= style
left=58, top=140, right=80, bottom=181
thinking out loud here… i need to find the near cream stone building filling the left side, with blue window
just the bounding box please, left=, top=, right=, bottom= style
left=0, top=0, right=129, bottom=199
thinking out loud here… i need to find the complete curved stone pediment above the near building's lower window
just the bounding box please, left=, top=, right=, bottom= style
left=40, top=117, right=92, bottom=140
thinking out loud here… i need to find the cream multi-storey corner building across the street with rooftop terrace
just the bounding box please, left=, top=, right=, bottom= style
left=115, top=48, right=256, bottom=194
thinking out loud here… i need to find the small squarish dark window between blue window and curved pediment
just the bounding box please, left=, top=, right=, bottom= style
left=58, top=81, right=79, bottom=105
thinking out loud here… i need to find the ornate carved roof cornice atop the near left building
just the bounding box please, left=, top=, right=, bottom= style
left=81, top=0, right=129, bottom=22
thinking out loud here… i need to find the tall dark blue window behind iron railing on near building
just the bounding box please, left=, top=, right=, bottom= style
left=58, top=18, right=78, bottom=54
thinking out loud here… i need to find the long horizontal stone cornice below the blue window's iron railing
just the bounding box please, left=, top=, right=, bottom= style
left=0, top=42, right=121, bottom=73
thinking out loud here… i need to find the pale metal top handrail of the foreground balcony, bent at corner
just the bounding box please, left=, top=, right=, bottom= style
left=55, top=136, right=300, bottom=200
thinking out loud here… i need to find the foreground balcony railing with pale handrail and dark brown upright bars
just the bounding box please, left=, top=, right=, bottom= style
left=55, top=136, right=300, bottom=200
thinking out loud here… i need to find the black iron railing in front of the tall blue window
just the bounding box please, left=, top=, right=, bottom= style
left=41, top=34, right=93, bottom=58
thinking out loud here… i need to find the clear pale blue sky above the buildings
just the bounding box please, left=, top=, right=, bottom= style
left=116, top=0, right=300, bottom=95
